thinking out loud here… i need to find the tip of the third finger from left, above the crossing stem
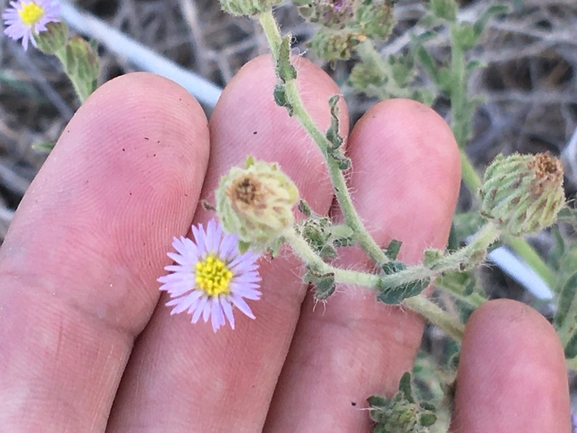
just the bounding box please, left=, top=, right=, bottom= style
left=349, top=99, right=461, bottom=262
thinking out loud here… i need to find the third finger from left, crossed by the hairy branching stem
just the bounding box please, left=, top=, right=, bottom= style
left=265, top=100, right=460, bottom=432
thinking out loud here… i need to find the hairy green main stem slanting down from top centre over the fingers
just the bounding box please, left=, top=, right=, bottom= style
left=259, top=12, right=389, bottom=265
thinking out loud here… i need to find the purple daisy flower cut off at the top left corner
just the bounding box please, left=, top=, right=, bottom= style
left=2, top=0, right=60, bottom=50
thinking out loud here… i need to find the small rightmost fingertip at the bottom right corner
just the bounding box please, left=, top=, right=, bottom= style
left=451, top=300, right=571, bottom=433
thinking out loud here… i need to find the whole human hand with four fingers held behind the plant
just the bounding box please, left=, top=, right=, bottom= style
left=0, top=57, right=570, bottom=433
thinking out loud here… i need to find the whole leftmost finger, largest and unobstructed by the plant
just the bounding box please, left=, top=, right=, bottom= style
left=0, top=74, right=208, bottom=433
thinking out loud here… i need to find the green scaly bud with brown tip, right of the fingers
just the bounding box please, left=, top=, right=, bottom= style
left=479, top=153, right=565, bottom=236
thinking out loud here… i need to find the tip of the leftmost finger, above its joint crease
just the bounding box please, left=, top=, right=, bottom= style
left=2, top=73, right=209, bottom=326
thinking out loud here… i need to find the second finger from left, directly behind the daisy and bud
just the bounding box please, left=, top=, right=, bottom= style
left=103, top=56, right=348, bottom=433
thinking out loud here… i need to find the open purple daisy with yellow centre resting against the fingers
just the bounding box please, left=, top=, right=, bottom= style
left=158, top=219, right=261, bottom=332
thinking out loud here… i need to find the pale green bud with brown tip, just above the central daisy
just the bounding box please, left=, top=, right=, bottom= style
left=215, top=156, right=299, bottom=251
